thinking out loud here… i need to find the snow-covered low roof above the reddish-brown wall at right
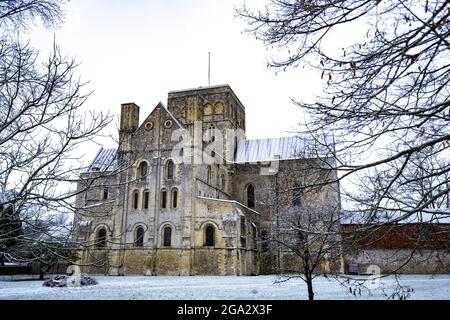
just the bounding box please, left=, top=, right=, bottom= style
left=341, top=209, right=450, bottom=224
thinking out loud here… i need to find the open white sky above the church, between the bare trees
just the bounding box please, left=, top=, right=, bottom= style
left=30, top=0, right=320, bottom=157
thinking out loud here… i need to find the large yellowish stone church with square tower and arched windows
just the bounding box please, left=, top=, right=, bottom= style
left=74, top=85, right=340, bottom=275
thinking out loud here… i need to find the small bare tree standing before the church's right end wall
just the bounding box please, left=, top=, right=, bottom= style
left=255, top=159, right=342, bottom=300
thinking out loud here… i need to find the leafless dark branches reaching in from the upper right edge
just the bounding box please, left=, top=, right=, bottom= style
left=237, top=0, right=450, bottom=220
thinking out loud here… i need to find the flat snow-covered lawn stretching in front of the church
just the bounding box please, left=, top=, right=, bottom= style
left=0, top=275, right=450, bottom=300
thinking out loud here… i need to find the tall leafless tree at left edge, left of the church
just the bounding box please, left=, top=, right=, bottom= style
left=0, top=0, right=111, bottom=272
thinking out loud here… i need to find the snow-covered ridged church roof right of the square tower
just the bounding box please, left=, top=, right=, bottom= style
left=235, top=136, right=332, bottom=163
